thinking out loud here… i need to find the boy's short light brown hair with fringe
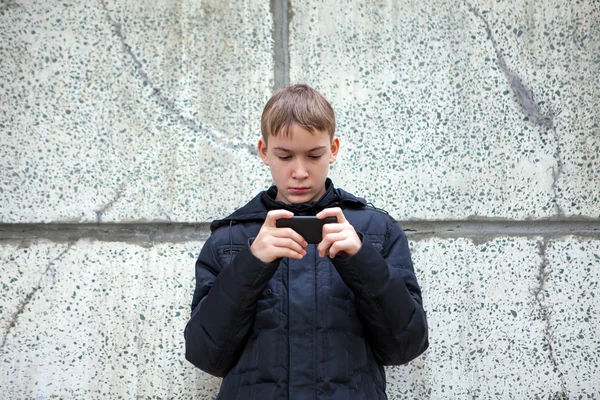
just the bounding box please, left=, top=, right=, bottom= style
left=260, top=84, right=335, bottom=143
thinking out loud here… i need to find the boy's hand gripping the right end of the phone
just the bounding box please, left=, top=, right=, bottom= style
left=317, top=207, right=362, bottom=258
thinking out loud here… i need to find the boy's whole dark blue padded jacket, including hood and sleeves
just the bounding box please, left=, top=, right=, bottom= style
left=185, top=180, right=428, bottom=400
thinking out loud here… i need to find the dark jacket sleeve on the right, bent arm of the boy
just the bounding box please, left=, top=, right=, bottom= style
left=332, top=218, right=429, bottom=365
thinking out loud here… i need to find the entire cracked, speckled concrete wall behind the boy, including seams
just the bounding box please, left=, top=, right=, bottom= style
left=0, top=0, right=600, bottom=399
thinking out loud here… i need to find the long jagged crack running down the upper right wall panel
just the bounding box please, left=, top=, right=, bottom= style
left=467, top=4, right=564, bottom=216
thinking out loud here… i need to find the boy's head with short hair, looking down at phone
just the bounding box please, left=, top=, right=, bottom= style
left=258, top=85, right=340, bottom=204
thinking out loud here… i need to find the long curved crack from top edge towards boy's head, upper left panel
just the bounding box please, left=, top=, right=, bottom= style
left=98, top=0, right=258, bottom=156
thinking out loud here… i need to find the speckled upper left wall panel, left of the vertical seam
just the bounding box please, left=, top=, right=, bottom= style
left=0, top=0, right=273, bottom=222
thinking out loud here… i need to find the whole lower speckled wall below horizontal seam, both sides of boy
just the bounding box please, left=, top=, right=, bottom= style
left=0, top=237, right=600, bottom=399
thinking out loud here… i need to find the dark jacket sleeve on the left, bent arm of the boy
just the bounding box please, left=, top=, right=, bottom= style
left=184, top=237, right=279, bottom=377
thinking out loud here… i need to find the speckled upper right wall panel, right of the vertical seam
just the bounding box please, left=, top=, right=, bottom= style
left=290, top=0, right=600, bottom=219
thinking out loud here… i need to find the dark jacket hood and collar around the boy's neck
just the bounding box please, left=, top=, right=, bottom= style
left=210, top=178, right=367, bottom=232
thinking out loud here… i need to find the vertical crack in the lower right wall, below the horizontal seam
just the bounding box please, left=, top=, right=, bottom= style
left=531, top=238, right=569, bottom=400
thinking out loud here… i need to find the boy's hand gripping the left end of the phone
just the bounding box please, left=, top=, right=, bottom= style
left=250, top=210, right=308, bottom=264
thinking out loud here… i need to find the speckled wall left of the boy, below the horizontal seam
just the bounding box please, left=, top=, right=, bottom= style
left=0, top=240, right=220, bottom=399
